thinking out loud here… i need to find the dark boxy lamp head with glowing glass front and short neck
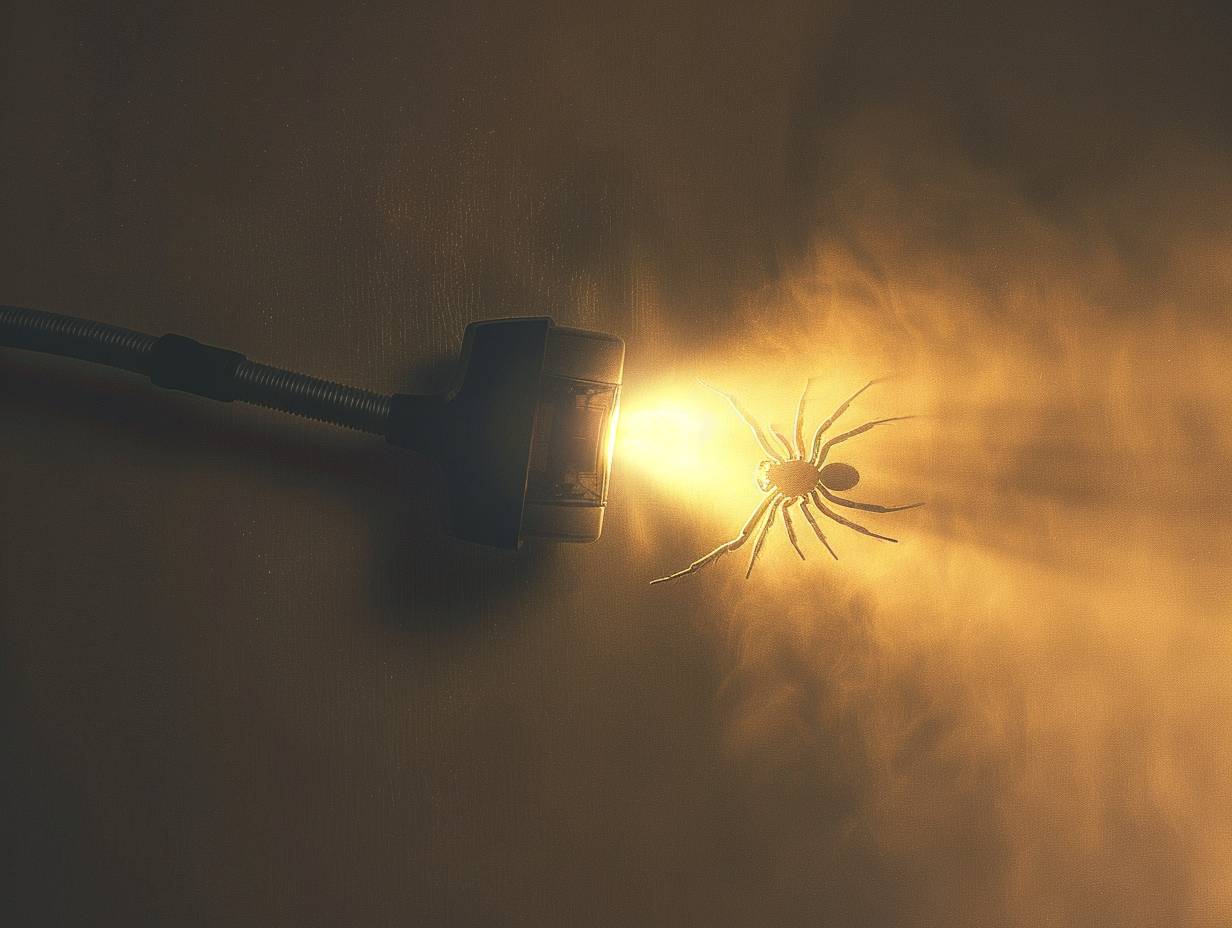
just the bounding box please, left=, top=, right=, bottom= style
left=386, top=318, right=625, bottom=547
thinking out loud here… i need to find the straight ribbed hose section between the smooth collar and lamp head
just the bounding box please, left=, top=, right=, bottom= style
left=226, top=360, right=389, bottom=435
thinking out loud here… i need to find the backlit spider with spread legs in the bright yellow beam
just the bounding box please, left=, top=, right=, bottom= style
left=650, top=378, right=924, bottom=585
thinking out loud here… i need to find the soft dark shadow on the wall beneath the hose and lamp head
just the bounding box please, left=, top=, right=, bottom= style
left=2, top=352, right=551, bottom=632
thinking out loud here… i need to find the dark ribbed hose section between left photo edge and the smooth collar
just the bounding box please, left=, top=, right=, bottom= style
left=0, top=306, right=158, bottom=373
